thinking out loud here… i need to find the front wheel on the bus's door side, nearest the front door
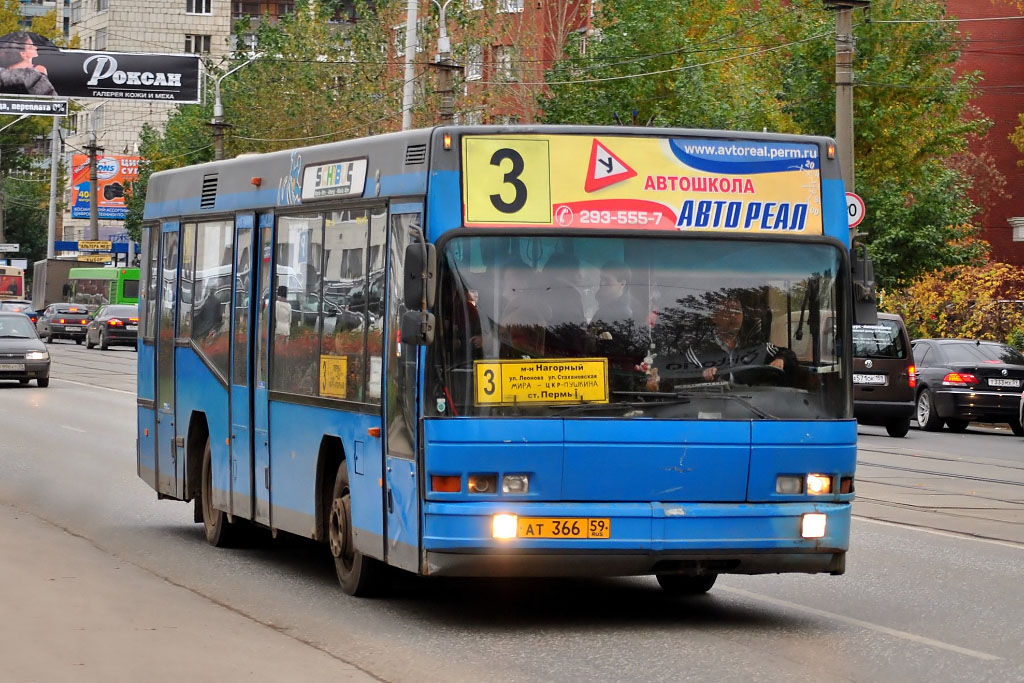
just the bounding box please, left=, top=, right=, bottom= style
left=328, top=463, right=386, bottom=597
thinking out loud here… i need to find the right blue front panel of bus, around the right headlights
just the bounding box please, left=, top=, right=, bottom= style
left=746, top=420, right=857, bottom=503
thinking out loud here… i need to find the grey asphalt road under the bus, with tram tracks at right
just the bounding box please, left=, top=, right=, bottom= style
left=0, top=343, right=1024, bottom=683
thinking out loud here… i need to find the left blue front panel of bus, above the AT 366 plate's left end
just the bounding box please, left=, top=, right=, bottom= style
left=423, top=418, right=565, bottom=501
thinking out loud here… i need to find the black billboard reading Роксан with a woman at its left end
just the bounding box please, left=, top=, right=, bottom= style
left=0, top=31, right=201, bottom=103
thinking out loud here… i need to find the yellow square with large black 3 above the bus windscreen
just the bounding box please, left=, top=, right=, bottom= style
left=462, top=135, right=551, bottom=224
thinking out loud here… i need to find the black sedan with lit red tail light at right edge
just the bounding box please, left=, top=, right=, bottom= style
left=912, top=339, right=1024, bottom=436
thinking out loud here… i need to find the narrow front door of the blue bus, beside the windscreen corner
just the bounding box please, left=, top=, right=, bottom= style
left=384, top=211, right=426, bottom=572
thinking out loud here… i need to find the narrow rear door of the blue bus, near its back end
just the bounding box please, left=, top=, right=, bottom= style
left=156, top=222, right=181, bottom=498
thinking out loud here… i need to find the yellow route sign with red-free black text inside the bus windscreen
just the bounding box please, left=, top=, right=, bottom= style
left=473, top=358, right=608, bottom=405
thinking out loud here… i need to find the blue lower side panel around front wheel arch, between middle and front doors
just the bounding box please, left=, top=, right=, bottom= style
left=268, top=401, right=384, bottom=558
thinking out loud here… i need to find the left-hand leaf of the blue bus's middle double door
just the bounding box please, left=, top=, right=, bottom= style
left=229, top=213, right=257, bottom=519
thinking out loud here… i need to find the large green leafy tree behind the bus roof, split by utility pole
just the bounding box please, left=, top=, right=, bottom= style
left=543, top=0, right=990, bottom=287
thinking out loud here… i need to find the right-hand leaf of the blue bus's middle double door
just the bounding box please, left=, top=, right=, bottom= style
left=250, top=214, right=273, bottom=525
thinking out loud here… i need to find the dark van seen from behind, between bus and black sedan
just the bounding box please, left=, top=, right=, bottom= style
left=853, top=313, right=916, bottom=437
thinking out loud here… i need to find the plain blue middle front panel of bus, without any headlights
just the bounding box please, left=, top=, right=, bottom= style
left=562, top=420, right=751, bottom=503
